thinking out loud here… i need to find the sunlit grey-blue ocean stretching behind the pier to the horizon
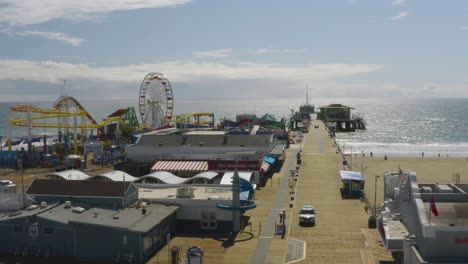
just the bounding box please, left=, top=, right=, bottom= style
left=0, top=98, right=468, bottom=157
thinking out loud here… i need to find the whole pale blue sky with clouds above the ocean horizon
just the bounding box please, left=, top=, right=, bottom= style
left=0, top=0, right=468, bottom=102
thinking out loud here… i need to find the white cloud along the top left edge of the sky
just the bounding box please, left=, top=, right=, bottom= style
left=0, top=0, right=191, bottom=26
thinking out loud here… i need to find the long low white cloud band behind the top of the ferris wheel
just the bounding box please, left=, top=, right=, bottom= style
left=0, top=60, right=382, bottom=83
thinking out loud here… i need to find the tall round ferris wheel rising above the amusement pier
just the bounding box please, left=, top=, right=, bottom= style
left=139, top=72, right=174, bottom=128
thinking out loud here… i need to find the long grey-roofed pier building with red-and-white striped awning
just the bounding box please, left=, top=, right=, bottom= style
left=123, top=134, right=287, bottom=184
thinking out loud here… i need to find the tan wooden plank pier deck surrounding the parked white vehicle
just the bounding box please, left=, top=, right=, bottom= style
left=288, top=123, right=392, bottom=263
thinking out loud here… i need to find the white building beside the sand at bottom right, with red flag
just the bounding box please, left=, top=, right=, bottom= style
left=378, top=172, right=468, bottom=264
